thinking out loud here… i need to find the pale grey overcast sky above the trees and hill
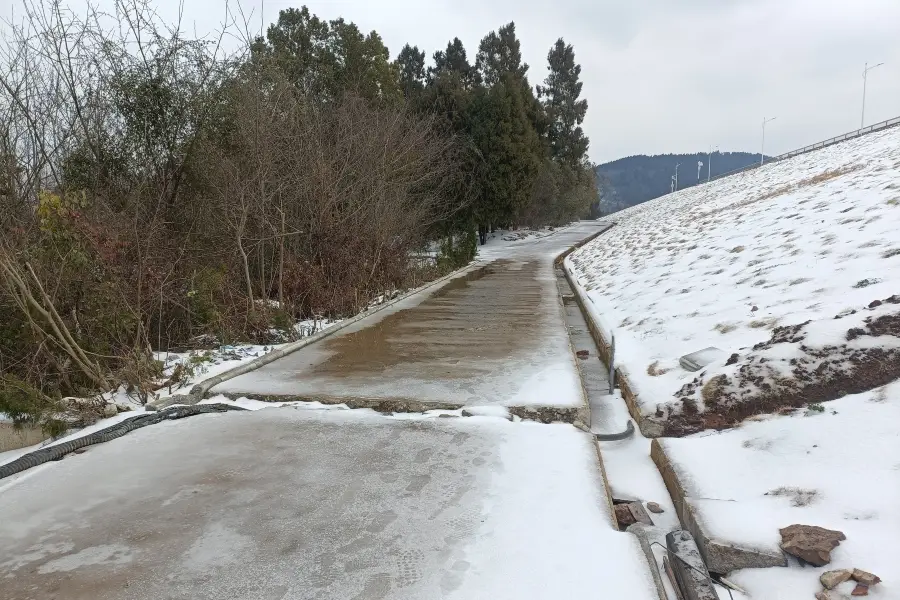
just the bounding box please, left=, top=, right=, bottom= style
left=7, top=0, right=900, bottom=162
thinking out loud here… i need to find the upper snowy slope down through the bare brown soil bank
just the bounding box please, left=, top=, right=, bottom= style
left=567, top=128, right=900, bottom=435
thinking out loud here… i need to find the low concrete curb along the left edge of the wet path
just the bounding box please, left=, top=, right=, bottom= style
left=150, top=260, right=485, bottom=408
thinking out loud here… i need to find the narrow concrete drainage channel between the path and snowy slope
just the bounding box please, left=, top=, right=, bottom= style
left=555, top=239, right=733, bottom=600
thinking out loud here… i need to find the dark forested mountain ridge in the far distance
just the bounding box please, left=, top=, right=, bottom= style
left=594, top=152, right=759, bottom=214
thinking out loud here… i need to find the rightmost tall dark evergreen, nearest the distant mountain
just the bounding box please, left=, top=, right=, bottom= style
left=537, top=38, right=589, bottom=168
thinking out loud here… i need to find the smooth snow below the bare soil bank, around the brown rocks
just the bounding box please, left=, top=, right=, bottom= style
left=663, top=382, right=900, bottom=600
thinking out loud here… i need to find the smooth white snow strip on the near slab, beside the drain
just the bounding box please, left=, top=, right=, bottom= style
left=448, top=419, right=658, bottom=600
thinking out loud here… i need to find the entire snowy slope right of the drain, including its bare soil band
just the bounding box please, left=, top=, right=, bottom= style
left=566, top=128, right=900, bottom=600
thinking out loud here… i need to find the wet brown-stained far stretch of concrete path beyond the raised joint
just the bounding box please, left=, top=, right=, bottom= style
left=211, top=222, right=604, bottom=408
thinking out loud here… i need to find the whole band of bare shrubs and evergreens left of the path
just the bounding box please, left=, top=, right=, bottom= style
left=0, top=0, right=596, bottom=429
